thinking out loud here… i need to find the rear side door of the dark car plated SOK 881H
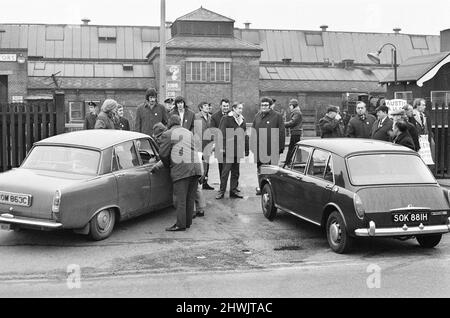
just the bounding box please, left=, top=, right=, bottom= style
left=304, top=149, right=334, bottom=224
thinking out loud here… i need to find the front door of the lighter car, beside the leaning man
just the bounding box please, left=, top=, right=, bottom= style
left=136, top=138, right=173, bottom=210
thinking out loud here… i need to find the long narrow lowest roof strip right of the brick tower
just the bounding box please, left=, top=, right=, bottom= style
left=259, top=80, right=386, bottom=93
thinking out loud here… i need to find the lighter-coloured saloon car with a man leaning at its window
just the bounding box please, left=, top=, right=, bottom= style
left=0, top=129, right=172, bottom=240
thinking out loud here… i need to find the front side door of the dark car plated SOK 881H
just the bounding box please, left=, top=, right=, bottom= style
left=277, top=146, right=312, bottom=216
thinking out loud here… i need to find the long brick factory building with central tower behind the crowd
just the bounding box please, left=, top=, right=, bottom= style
left=0, top=8, right=440, bottom=134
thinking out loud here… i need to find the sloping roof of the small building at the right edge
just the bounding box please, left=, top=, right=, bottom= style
left=380, top=52, right=450, bottom=87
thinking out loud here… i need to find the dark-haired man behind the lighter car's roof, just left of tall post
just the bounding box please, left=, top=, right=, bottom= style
left=135, top=88, right=167, bottom=136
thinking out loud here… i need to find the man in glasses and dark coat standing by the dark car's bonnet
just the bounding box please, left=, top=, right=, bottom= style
left=252, top=97, right=286, bottom=195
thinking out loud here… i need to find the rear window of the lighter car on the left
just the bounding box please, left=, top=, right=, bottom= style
left=21, top=146, right=100, bottom=175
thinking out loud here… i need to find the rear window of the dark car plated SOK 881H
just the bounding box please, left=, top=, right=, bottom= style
left=347, top=154, right=436, bottom=186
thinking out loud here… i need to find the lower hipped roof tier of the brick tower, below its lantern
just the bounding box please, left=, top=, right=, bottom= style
left=167, top=36, right=262, bottom=51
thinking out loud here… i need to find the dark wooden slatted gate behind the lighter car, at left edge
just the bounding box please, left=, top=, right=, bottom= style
left=0, top=93, right=64, bottom=172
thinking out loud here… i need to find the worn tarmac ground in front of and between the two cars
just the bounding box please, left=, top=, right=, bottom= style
left=0, top=157, right=450, bottom=297
